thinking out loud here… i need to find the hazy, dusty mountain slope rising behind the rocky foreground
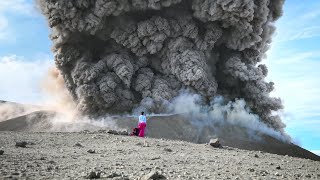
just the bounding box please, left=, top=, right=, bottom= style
left=0, top=107, right=320, bottom=161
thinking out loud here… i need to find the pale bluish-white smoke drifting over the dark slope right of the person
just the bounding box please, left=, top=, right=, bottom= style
left=168, top=90, right=291, bottom=142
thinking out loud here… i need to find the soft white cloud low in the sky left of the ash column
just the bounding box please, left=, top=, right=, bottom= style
left=0, top=55, right=53, bottom=104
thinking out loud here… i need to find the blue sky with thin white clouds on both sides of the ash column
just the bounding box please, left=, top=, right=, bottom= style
left=0, top=0, right=320, bottom=154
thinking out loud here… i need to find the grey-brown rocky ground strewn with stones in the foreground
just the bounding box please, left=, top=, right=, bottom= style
left=0, top=131, right=320, bottom=179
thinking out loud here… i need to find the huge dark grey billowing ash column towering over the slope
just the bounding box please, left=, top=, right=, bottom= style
left=38, top=0, right=284, bottom=130
